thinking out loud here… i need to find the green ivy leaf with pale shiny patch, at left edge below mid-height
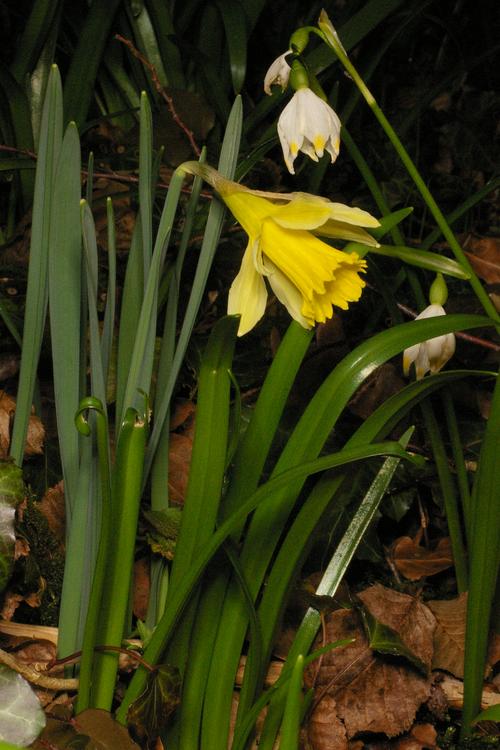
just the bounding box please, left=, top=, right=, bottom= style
left=0, top=461, right=24, bottom=591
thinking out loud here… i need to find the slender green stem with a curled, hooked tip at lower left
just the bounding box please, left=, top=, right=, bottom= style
left=75, top=396, right=111, bottom=713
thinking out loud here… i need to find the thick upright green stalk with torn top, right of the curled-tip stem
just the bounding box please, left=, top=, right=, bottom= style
left=91, top=409, right=147, bottom=711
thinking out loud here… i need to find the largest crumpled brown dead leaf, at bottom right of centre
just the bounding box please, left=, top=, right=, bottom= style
left=305, top=610, right=431, bottom=739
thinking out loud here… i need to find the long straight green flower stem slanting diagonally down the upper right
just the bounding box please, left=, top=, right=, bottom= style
left=319, top=11, right=500, bottom=323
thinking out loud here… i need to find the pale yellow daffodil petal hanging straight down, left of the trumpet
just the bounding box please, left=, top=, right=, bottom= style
left=227, top=241, right=267, bottom=336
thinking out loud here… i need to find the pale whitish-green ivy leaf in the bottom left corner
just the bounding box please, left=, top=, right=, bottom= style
left=0, top=664, right=45, bottom=747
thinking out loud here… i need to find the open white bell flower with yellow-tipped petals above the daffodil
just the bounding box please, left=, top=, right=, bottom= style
left=278, top=88, right=340, bottom=174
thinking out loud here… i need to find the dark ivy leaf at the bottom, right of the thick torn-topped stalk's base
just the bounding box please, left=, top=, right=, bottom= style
left=127, top=664, right=181, bottom=742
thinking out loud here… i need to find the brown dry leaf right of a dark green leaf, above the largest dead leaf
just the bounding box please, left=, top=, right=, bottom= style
left=358, top=583, right=436, bottom=670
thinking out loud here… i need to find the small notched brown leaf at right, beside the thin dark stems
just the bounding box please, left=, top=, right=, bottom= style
left=391, top=536, right=453, bottom=581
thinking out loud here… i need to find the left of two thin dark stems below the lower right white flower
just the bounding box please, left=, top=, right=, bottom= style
left=421, top=401, right=467, bottom=592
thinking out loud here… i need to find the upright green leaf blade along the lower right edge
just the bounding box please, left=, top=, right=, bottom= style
left=462, top=375, right=500, bottom=738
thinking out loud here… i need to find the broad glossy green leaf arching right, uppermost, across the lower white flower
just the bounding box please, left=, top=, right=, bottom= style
left=199, top=316, right=491, bottom=747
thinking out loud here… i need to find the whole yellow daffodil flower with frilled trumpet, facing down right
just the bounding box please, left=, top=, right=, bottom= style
left=179, top=162, right=379, bottom=336
